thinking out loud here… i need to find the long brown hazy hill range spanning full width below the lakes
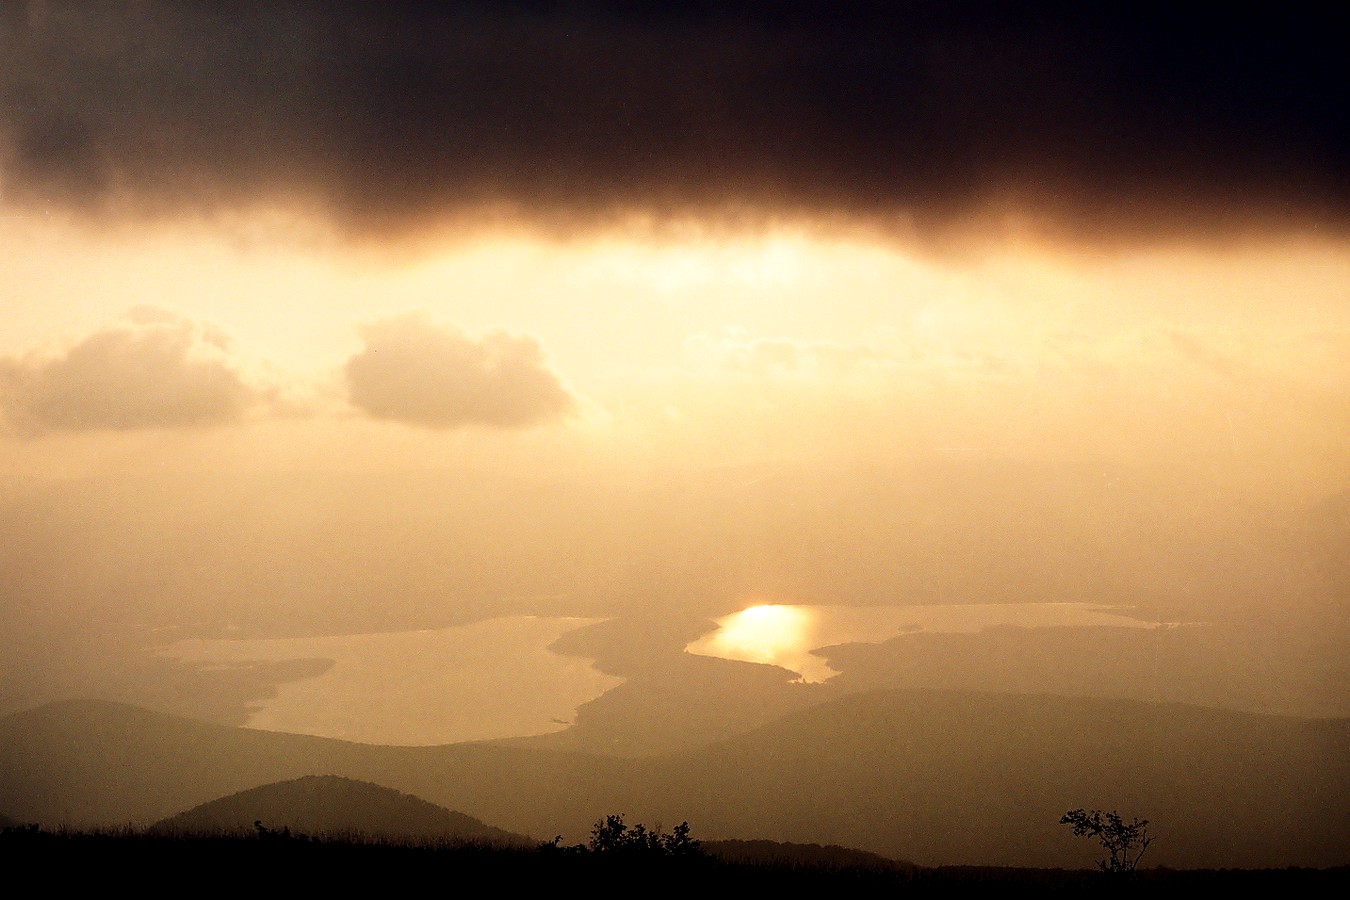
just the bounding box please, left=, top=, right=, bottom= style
left=0, top=691, right=1350, bottom=868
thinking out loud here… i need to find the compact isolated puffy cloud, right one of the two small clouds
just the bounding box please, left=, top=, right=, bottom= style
left=346, top=313, right=574, bottom=428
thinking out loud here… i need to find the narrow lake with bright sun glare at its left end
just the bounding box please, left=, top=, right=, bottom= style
left=684, top=603, right=1153, bottom=683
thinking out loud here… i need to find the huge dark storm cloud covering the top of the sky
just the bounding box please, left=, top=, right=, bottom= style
left=0, top=0, right=1350, bottom=236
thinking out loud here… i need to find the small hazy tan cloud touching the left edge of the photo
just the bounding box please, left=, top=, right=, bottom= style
left=0, top=308, right=258, bottom=436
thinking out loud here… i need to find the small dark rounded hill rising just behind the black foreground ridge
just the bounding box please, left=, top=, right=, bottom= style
left=151, top=775, right=526, bottom=846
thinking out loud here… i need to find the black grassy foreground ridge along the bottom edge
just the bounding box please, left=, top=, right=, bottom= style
left=0, top=824, right=1350, bottom=896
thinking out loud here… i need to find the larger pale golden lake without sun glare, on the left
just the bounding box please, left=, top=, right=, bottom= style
left=159, top=615, right=622, bottom=745
